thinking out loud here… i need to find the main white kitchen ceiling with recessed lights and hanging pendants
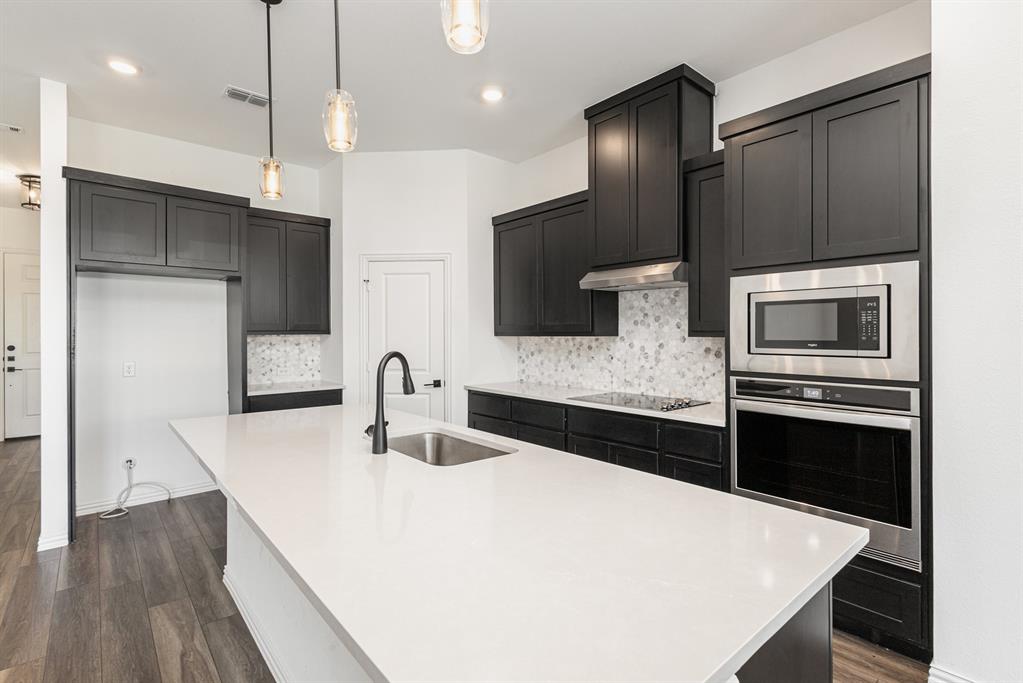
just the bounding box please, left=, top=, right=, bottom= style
left=0, top=0, right=906, bottom=168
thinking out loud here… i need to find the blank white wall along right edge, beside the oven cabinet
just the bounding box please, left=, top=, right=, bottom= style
left=931, top=0, right=1023, bottom=681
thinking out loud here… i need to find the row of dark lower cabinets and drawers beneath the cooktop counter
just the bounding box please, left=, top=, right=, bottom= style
left=469, top=392, right=727, bottom=490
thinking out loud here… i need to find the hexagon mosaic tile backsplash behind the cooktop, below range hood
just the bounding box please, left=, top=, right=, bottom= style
left=519, top=288, right=724, bottom=401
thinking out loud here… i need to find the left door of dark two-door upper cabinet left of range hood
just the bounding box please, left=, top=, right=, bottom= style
left=494, top=218, right=539, bottom=334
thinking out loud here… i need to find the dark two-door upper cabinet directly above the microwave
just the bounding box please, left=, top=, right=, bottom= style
left=719, top=55, right=931, bottom=269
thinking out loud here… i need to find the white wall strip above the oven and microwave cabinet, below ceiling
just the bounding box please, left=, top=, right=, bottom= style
left=714, top=0, right=931, bottom=149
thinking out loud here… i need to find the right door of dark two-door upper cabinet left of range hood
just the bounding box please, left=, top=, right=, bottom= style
left=537, top=203, right=593, bottom=332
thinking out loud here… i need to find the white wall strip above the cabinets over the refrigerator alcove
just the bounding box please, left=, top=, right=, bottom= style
left=68, top=118, right=319, bottom=215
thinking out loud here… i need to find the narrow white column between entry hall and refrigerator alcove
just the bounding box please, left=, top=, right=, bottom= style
left=39, top=79, right=68, bottom=550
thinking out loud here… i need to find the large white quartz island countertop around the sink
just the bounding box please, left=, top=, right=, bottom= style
left=171, top=406, right=868, bottom=681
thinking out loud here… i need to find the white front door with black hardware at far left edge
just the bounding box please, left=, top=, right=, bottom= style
left=3, top=254, right=41, bottom=438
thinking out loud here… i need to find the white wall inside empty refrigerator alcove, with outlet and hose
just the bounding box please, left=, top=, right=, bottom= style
left=76, top=273, right=227, bottom=514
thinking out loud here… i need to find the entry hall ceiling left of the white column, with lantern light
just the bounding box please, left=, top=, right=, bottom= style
left=0, top=69, right=39, bottom=209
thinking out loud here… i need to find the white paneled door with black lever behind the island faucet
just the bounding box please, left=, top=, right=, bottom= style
left=365, top=260, right=448, bottom=420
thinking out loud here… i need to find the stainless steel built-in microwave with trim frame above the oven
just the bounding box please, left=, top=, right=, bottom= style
left=730, top=261, right=920, bottom=381
